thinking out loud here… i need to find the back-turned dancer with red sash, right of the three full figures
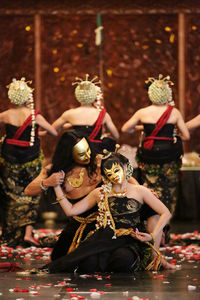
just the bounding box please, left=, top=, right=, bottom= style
left=122, top=75, right=190, bottom=245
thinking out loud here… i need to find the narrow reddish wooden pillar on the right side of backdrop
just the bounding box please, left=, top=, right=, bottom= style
left=178, top=13, right=186, bottom=118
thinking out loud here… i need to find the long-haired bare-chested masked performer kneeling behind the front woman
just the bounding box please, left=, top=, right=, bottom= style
left=25, top=130, right=101, bottom=260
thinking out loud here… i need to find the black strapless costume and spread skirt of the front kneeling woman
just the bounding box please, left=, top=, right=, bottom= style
left=43, top=197, right=152, bottom=273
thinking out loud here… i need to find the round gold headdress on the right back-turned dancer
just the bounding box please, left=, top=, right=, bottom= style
left=145, top=74, right=174, bottom=105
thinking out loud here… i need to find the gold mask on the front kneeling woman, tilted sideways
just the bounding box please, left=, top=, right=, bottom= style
left=104, top=163, right=125, bottom=184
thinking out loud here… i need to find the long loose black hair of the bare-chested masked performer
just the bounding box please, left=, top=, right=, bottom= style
left=48, top=130, right=96, bottom=176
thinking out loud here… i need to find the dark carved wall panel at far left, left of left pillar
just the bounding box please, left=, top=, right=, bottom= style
left=0, top=16, right=34, bottom=135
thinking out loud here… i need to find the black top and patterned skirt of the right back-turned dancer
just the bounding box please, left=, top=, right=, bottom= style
left=137, top=107, right=183, bottom=217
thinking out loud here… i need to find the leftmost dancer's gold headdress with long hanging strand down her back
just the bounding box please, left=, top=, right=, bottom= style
left=7, top=77, right=35, bottom=146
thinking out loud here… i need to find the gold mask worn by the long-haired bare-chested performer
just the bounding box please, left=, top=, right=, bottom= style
left=72, top=138, right=91, bottom=165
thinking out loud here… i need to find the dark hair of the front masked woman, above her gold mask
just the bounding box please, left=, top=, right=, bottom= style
left=101, top=152, right=128, bottom=175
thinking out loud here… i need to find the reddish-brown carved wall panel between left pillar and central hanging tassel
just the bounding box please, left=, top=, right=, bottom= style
left=41, top=15, right=99, bottom=155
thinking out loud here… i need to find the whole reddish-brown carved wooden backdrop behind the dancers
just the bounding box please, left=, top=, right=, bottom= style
left=0, top=1, right=200, bottom=156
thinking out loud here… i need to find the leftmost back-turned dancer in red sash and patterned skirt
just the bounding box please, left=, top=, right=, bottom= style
left=0, top=78, right=57, bottom=247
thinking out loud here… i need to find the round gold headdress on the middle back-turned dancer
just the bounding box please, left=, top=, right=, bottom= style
left=72, top=74, right=100, bottom=104
